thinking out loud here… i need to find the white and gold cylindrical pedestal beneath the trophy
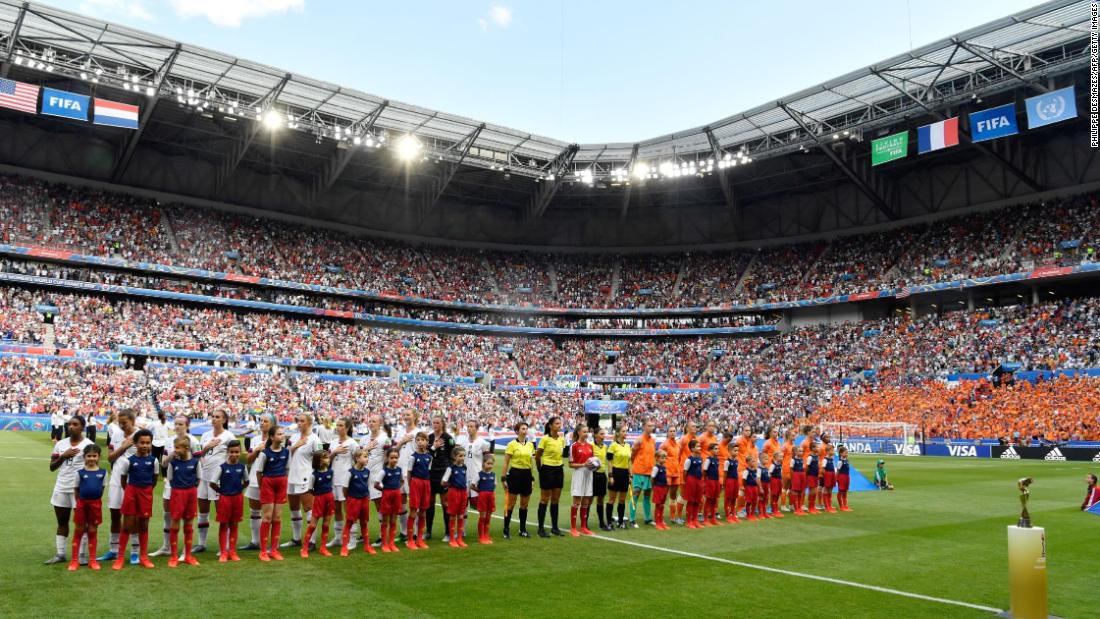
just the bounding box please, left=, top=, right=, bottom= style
left=1001, top=526, right=1047, bottom=619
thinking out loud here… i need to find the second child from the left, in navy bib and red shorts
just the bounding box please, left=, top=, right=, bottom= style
left=111, top=430, right=161, bottom=570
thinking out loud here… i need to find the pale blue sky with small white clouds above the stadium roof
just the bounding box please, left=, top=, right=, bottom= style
left=50, top=0, right=1035, bottom=143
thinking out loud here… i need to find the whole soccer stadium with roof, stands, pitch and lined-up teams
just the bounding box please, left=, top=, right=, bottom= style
left=0, top=0, right=1100, bottom=619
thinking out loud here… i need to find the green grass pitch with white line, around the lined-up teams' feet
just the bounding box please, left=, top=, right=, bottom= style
left=0, top=432, right=1100, bottom=619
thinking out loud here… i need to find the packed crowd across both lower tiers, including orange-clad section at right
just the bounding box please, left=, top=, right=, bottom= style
left=0, top=289, right=1100, bottom=436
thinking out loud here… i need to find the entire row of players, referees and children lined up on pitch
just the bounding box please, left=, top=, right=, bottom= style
left=47, top=410, right=849, bottom=571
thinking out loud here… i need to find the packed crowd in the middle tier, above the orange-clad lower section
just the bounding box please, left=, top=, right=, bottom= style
left=0, top=281, right=1100, bottom=391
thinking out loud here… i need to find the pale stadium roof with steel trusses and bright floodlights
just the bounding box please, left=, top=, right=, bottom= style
left=0, top=0, right=1089, bottom=183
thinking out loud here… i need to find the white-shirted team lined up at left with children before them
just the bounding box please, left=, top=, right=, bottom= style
left=46, top=410, right=495, bottom=570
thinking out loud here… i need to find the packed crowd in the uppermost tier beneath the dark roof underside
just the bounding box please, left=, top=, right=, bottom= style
left=0, top=176, right=1100, bottom=308
